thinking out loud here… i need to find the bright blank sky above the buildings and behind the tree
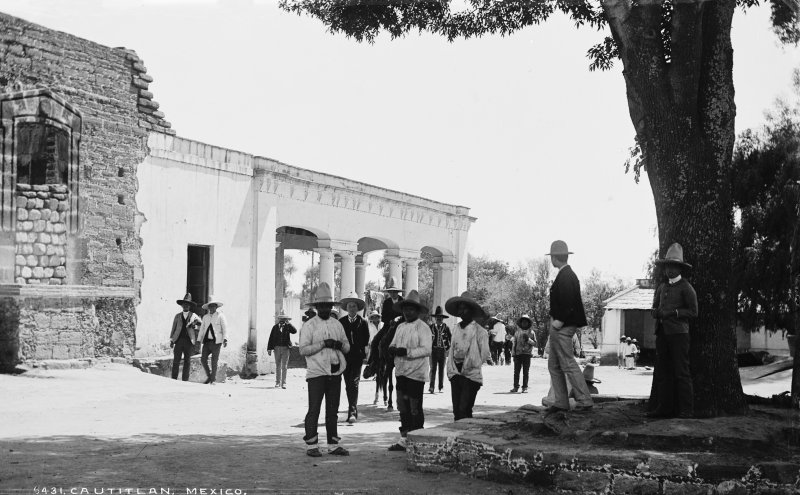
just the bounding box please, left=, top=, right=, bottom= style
left=0, top=0, right=800, bottom=286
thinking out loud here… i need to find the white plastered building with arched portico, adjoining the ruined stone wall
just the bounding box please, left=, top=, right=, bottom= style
left=136, top=133, right=475, bottom=373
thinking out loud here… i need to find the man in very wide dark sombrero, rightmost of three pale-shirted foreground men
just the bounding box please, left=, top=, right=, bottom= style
left=444, top=292, right=491, bottom=421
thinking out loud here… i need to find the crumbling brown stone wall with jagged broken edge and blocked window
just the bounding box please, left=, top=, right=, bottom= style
left=0, top=13, right=174, bottom=369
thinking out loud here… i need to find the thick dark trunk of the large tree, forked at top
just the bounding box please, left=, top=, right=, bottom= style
left=603, top=0, right=747, bottom=417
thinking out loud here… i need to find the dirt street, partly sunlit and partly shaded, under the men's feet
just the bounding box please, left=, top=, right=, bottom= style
left=0, top=359, right=791, bottom=495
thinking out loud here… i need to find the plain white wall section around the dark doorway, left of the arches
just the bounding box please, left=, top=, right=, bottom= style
left=136, top=149, right=253, bottom=369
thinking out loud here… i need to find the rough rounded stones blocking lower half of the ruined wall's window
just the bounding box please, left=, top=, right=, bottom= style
left=14, top=184, right=69, bottom=285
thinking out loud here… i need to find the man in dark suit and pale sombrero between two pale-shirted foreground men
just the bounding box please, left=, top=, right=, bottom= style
left=339, top=292, right=369, bottom=424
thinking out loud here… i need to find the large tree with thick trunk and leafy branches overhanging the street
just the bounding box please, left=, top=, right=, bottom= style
left=281, top=0, right=800, bottom=416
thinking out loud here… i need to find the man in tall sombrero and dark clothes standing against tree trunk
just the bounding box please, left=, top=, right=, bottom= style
left=647, top=242, right=697, bottom=418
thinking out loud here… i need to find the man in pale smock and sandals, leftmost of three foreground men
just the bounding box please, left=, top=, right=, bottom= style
left=300, top=282, right=350, bottom=457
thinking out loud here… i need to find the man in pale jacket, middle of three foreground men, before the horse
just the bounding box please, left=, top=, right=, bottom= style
left=389, top=290, right=431, bottom=451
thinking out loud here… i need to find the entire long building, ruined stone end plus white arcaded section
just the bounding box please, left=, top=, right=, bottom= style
left=0, top=14, right=475, bottom=373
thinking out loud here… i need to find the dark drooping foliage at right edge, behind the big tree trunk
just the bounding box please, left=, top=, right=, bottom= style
left=733, top=70, right=800, bottom=333
